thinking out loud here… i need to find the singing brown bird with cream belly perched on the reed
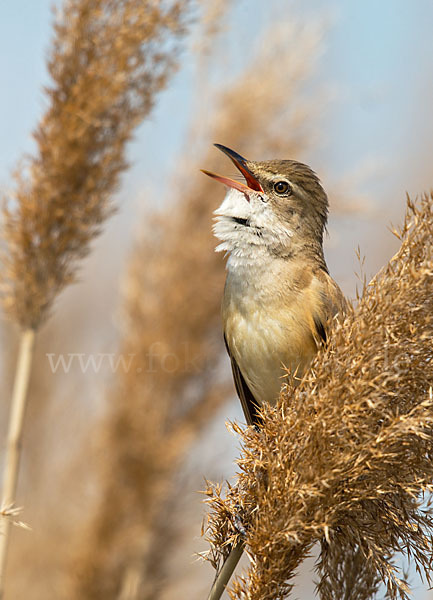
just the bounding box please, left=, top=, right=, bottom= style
left=202, top=144, right=346, bottom=600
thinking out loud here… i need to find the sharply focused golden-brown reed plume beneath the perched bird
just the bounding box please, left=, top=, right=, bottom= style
left=208, top=195, right=433, bottom=600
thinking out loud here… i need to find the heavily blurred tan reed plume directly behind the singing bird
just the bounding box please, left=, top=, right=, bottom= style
left=70, top=14, right=320, bottom=600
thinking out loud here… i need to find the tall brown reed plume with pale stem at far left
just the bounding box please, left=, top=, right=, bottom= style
left=0, top=0, right=190, bottom=596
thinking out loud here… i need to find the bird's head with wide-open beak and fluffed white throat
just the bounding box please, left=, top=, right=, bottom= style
left=203, top=144, right=328, bottom=261
